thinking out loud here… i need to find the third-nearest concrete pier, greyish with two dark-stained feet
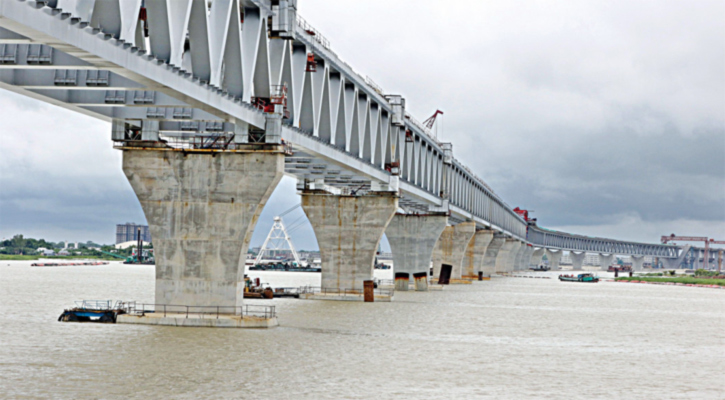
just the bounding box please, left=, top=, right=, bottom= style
left=385, top=214, right=448, bottom=291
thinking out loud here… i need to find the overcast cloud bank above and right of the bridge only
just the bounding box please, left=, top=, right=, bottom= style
left=300, top=0, right=725, bottom=241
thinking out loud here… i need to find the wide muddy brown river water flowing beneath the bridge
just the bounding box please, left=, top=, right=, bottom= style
left=0, top=261, right=725, bottom=399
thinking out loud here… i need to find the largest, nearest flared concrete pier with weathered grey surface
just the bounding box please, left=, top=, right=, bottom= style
left=123, top=146, right=284, bottom=308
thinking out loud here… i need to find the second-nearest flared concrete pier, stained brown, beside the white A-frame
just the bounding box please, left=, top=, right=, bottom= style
left=302, top=192, right=398, bottom=292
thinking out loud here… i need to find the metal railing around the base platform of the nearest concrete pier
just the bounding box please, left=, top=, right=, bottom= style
left=122, top=302, right=277, bottom=319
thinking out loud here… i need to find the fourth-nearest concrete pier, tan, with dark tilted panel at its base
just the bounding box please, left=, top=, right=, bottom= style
left=433, top=222, right=476, bottom=283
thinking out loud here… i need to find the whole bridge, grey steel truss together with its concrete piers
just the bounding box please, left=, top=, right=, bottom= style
left=0, top=0, right=686, bottom=306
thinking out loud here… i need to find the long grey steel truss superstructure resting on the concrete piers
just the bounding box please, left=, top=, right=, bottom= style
left=0, top=0, right=680, bottom=258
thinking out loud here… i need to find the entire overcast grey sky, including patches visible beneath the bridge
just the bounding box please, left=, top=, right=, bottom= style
left=0, top=0, right=725, bottom=249
